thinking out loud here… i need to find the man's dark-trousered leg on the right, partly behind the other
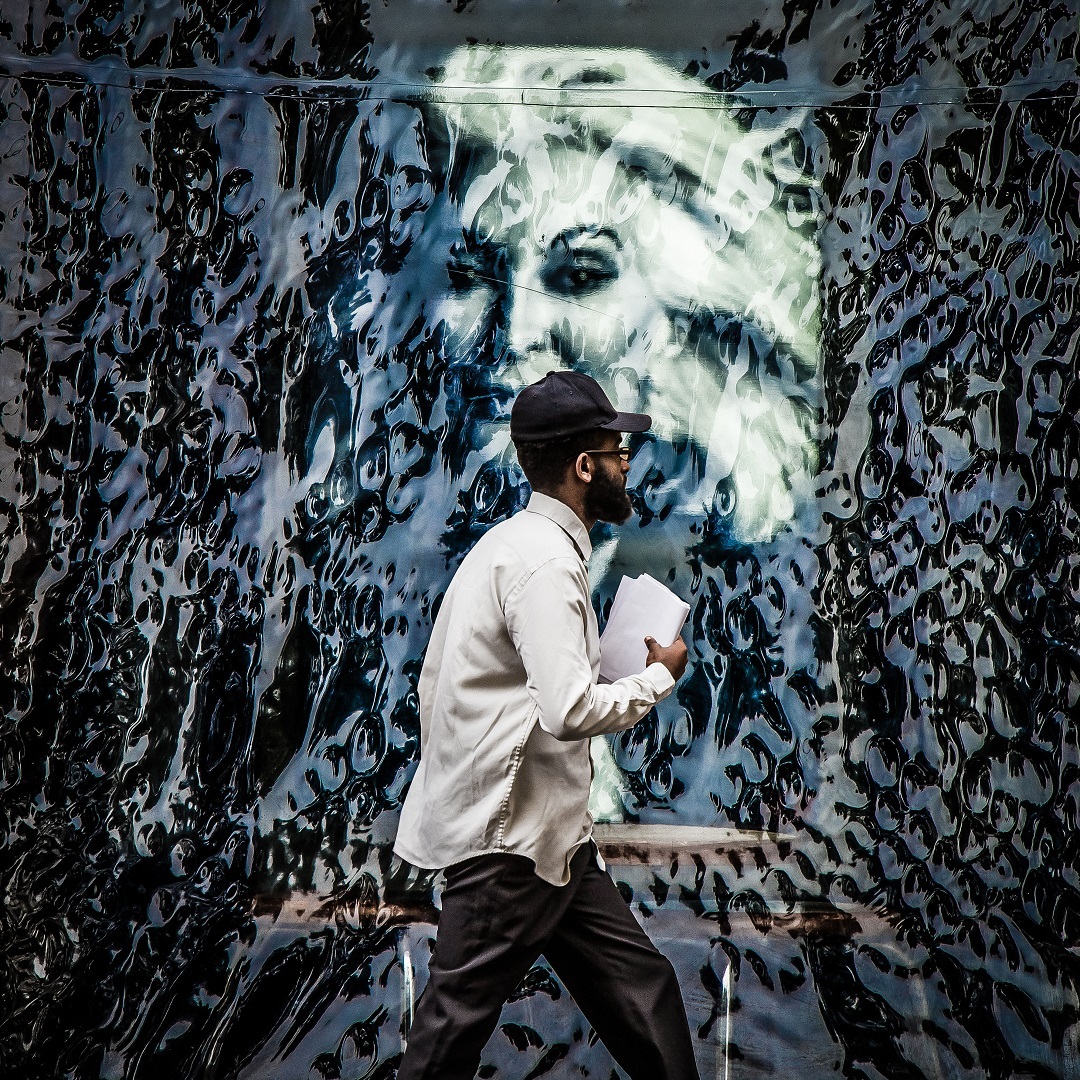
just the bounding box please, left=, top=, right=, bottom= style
left=543, top=859, right=698, bottom=1080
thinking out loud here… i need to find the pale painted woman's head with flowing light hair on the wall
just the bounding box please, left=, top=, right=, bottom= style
left=427, top=50, right=818, bottom=541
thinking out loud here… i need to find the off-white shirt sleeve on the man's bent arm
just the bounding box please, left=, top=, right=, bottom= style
left=503, top=557, right=675, bottom=741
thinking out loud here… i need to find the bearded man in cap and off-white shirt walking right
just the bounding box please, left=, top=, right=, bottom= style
left=394, top=370, right=698, bottom=1080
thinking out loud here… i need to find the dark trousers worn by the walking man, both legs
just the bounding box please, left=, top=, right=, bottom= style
left=397, top=843, right=698, bottom=1080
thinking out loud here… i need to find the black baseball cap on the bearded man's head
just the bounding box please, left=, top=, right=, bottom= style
left=510, top=372, right=652, bottom=443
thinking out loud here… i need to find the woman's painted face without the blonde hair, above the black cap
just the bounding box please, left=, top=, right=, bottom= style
left=440, top=145, right=691, bottom=429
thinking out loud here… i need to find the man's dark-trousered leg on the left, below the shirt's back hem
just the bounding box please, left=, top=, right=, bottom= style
left=397, top=854, right=572, bottom=1080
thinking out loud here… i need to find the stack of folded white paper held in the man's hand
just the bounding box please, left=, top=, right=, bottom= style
left=600, top=573, right=690, bottom=683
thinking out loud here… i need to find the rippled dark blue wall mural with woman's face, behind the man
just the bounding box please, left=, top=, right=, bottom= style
left=0, top=0, right=1080, bottom=1080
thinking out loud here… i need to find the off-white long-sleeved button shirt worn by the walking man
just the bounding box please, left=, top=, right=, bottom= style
left=394, top=492, right=675, bottom=885
